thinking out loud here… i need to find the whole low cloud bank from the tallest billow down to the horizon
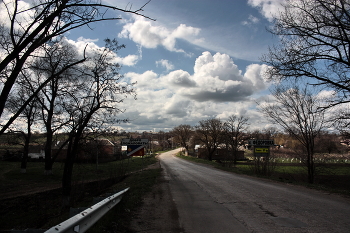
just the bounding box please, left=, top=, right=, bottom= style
left=119, top=52, right=268, bottom=130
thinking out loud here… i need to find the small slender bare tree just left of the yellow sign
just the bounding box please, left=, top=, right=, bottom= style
left=223, top=115, right=248, bottom=164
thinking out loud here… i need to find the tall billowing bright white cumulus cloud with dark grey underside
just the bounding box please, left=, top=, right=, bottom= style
left=174, top=52, right=266, bottom=102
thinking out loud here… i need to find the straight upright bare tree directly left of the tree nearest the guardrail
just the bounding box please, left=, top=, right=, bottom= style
left=30, top=37, right=81, bottom=175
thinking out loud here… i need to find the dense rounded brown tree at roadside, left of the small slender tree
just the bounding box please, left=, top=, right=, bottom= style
left=196, top=118, right=223, bottom=160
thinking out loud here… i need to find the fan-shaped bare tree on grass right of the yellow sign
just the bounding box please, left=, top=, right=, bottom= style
left=259, top=85, right=325, bottom=183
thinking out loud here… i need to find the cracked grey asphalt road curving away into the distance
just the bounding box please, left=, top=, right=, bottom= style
left=160, top=151, right=350, bottom=233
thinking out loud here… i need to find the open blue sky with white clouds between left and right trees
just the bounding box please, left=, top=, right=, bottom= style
left=66, top=0, right=288, bottom=132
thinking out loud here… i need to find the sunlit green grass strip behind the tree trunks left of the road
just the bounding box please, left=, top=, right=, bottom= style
left=0, top=156, right=157, bottom=198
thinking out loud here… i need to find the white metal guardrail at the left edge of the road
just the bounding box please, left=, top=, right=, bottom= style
left=45, top=188, right=129, bottom=233
